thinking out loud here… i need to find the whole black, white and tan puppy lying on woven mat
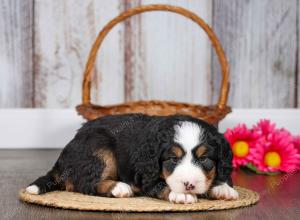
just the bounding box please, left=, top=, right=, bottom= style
left=26, top=114, right=238, bottom=203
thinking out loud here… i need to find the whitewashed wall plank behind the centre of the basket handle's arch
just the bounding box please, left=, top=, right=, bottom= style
left=125, top=0, right=211, bottom=103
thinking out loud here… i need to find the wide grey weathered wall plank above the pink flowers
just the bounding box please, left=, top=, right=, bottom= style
left=213, top=0, right=297, bottom=108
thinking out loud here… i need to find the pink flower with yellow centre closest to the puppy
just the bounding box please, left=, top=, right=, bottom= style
left=224, top=124, right=260, bottom=168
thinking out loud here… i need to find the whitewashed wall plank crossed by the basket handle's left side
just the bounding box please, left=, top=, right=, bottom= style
left=34, top=0, right=124, bottom=107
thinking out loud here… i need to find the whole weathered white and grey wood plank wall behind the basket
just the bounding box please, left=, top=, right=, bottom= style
left=0, top=0, right=300, bottom=108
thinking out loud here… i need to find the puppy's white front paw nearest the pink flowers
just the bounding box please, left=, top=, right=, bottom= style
left=209, top=183, right=239, bottom=200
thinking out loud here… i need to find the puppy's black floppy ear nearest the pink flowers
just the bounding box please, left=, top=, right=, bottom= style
left=213, top=133, right=233, bottom=186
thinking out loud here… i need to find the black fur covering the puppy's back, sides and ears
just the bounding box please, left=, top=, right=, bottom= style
left=30, top=114, right=232, bottom=197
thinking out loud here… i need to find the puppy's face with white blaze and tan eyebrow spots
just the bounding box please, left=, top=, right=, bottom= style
left=161, top=121, right=231, bottom=194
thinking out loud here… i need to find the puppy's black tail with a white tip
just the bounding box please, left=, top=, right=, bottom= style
left=26, top=170, right=61, bottom=195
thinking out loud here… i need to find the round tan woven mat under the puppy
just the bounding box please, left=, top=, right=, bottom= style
left=19, top=187, right=259, bottom=212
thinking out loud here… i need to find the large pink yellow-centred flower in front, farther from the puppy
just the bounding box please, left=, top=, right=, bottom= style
left=252, top=129, right=300, bottom=172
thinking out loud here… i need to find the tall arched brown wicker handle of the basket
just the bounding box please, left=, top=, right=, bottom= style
left=82, top=5, right=229, bottom=109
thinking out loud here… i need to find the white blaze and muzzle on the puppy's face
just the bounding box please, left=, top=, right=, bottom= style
left=166, top=121, right=208, bottom=194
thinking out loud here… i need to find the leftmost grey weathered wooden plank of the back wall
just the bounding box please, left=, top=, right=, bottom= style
left=0, top=0, right=33, bottom=108
